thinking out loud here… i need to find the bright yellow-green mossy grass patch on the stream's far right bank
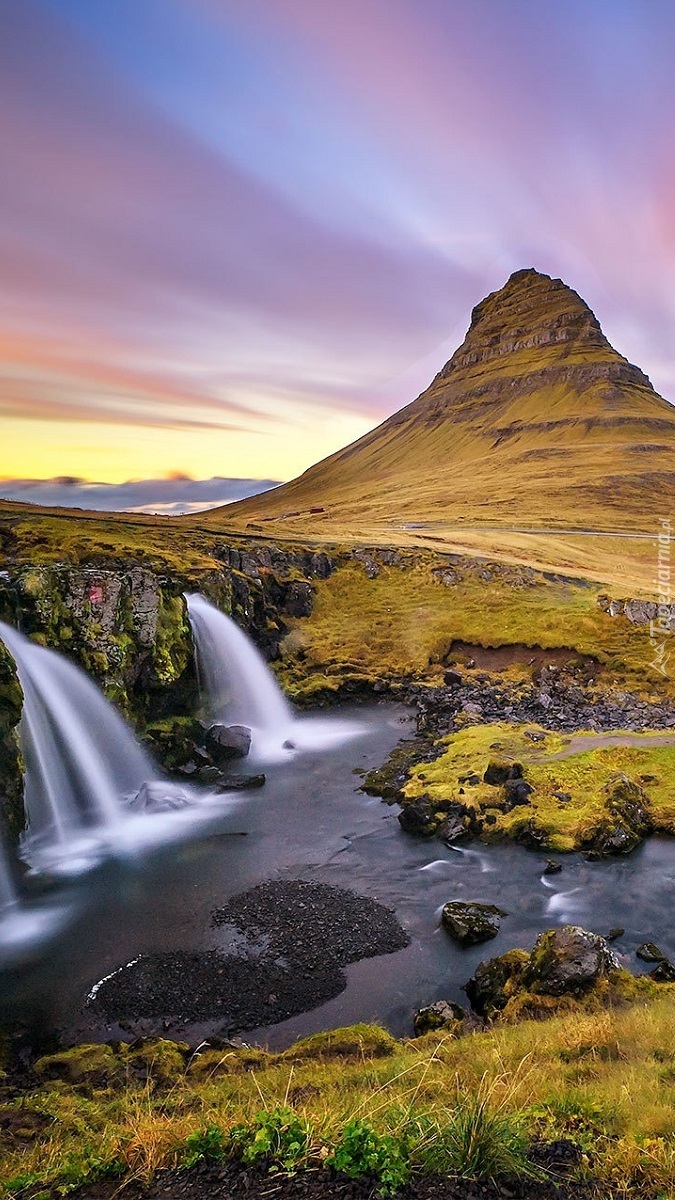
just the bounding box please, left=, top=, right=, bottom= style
left=405, top=724, right=675, bottom=852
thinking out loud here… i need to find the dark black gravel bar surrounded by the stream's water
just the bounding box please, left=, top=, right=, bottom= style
left=88, top=880, right=410, bottom=1036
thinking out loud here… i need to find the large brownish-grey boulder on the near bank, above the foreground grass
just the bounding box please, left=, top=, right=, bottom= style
left=522, top=925, right=619, bottom=996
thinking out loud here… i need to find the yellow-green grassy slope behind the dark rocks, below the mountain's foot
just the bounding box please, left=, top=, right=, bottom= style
left=275, top=564, right=675, bottom=695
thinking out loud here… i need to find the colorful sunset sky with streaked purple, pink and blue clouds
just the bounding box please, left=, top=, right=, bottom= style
left=0, top=0, right=675, bottom=511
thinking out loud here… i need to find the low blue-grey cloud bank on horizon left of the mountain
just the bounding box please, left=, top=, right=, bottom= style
left=0, top=475, right=280, bottom=516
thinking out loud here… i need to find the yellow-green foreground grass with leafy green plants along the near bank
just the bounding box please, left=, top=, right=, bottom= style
left=6, top=1003, right=675, bottom=1196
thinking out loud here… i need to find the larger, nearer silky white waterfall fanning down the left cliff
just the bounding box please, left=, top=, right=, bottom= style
left=0, top=622, right=205, bottom=873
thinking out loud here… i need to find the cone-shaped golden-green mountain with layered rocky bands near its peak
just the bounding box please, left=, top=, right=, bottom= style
left=201, top=269, right=675, bottom=533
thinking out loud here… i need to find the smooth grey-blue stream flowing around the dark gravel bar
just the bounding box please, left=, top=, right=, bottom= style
left=0, top=702, right=675, bottom=1049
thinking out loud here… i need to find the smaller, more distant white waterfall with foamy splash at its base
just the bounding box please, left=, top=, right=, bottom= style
left=185, top=593, right=359, bottom=762
